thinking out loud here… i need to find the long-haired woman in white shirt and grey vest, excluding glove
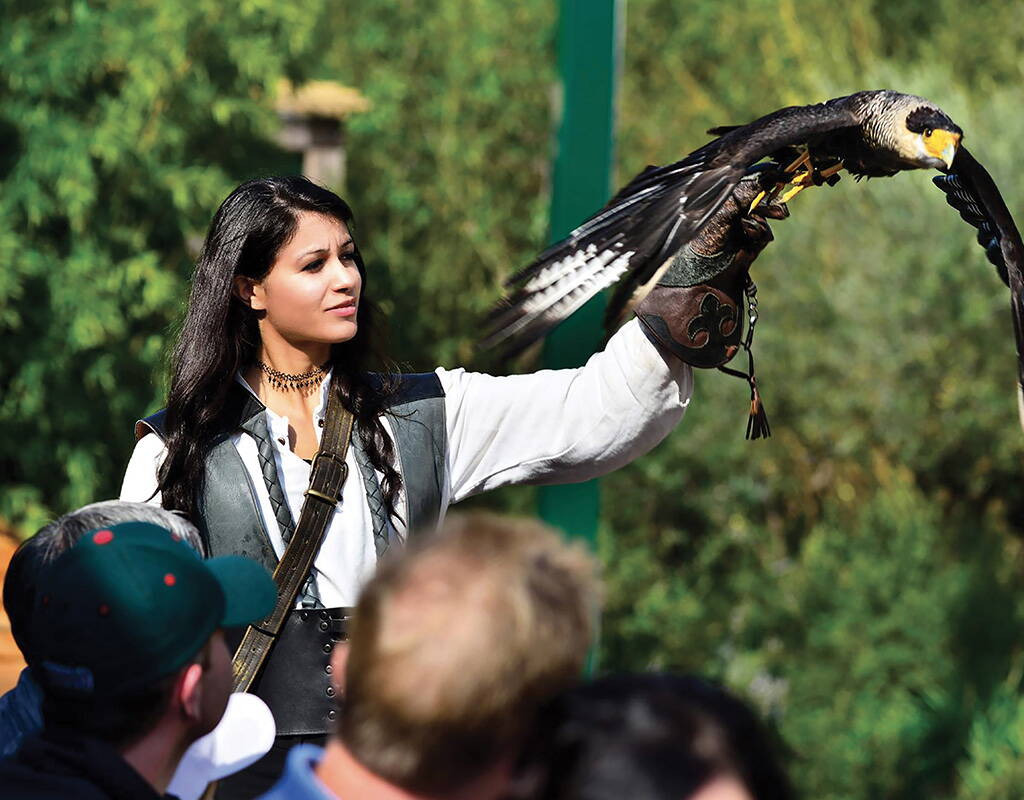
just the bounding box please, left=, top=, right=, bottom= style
left=122, top=177, right=770, bottom=796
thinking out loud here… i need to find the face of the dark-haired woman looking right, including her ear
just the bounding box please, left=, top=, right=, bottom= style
left=236, top=212, right=362, bottom=344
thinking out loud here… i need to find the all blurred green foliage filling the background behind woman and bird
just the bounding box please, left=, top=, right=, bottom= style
left=6, top=0, right=1024, bottom=800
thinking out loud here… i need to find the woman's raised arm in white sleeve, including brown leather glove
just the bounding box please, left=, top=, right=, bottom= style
left=437, top=177, right=787, bottom=502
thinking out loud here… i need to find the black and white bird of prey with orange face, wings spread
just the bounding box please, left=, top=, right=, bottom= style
left=481, top=89, right=1024, bottom=383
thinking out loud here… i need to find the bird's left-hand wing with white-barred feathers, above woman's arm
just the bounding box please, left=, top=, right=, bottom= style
left=481, top=93, right=864, bottom=355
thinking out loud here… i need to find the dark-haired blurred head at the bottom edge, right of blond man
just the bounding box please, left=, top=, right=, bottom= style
left=508, top=674, right=795, bottom=800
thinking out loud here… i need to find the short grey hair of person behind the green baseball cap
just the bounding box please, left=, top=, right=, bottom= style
left=3, top=500, right=204, bottom=664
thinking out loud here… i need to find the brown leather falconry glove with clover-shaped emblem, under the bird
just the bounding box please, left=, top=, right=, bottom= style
left=636, top=173, right=790, bottom=368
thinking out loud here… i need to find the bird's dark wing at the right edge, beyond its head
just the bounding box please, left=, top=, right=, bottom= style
left=932, top=146, right=1024, bottom=387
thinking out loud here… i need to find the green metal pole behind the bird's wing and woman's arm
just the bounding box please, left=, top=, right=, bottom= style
left=539, top=0, right=622, bottom=547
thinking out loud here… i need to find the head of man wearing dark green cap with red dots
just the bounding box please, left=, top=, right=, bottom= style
left=29, top=522, right=276, bottom=756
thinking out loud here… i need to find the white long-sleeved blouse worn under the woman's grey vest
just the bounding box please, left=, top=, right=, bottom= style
left=121, top=320, right=693, bottom=607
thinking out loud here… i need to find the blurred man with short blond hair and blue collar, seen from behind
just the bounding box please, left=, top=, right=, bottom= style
left=263, top=514, right=599, bottom=800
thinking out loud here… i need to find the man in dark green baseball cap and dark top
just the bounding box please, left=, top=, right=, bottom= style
left=0, top=514, right=275, bottom=800
